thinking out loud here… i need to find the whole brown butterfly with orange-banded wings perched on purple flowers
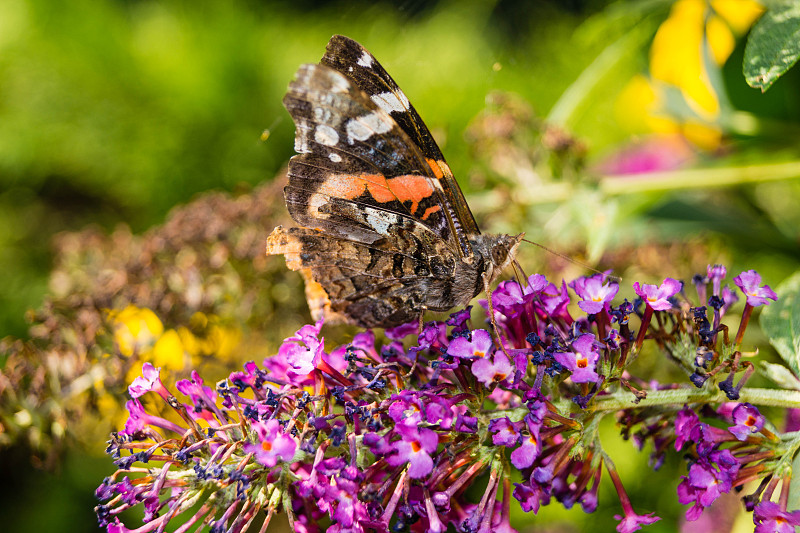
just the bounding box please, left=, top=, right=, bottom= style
left=267, top=36, right=521, bottom=327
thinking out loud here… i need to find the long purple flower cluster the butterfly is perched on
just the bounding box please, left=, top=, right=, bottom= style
left=97, top=269, right=785, bottom=533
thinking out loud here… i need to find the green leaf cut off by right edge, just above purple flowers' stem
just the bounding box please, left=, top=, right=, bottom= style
left=760, top=272, right=800, bottom=376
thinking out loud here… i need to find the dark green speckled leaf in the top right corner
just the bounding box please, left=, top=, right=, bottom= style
left=742, top=2, right=800, bottom=92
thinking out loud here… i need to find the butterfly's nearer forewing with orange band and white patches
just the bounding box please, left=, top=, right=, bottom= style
left=284, top=65, right=458, bottom=250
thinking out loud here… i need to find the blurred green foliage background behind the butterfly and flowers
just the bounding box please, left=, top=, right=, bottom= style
left=0, top=0, right=800, bottom=531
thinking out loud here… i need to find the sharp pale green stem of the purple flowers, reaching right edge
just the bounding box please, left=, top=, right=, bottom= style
left=594, top=388, right=800, bottom=411
